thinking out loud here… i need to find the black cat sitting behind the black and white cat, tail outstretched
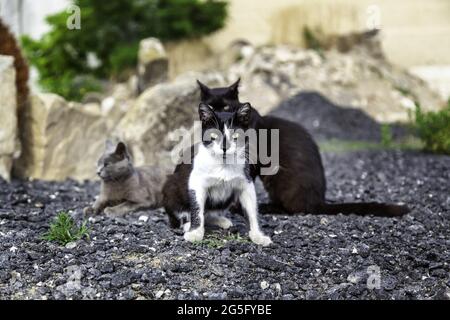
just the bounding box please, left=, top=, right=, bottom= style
left=198, top=80, right=409, bottom=217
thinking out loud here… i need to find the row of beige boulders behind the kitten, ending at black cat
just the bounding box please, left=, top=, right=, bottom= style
left=13, top=74, right=224, bottom=180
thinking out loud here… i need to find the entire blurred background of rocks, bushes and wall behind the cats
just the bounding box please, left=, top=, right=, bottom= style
left=0, top=0, right=450, bottom=180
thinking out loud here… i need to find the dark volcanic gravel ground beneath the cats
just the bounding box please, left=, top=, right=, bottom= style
left=0, top=152, right=450, bottom=299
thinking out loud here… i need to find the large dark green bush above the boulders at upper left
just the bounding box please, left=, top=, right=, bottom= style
left=22, top=0, right=226, bottom=100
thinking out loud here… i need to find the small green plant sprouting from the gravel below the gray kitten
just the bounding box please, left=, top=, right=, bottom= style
left=43, top=211, right=89, bottom=246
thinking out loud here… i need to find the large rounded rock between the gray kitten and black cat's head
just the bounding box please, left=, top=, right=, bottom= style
left=112, top=73, right=225, bottom=166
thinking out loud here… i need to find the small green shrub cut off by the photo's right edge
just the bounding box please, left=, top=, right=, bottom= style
left=414, top=101, right=450, bottom=154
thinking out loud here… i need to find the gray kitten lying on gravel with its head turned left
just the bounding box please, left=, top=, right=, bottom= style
left=84, top=140, right=168, bottom=217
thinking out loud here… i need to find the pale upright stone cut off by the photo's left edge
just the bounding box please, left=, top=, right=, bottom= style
left=0, top=56, right=19, bottom=180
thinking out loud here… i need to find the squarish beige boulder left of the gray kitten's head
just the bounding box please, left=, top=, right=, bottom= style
left=15, top=94, right=108, bottom=180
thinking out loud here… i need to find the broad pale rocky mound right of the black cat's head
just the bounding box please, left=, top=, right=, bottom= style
left=228, top=39, right=445, bottom=122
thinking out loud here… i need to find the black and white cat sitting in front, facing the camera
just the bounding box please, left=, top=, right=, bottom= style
left=163, top=103, right=272, bottom=246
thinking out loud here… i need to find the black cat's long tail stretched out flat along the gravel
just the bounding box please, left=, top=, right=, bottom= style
left=314, top=202, right=410, bottom=217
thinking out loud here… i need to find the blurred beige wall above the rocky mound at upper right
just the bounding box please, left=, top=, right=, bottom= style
left=208, top=0, right=450, bottom=67
